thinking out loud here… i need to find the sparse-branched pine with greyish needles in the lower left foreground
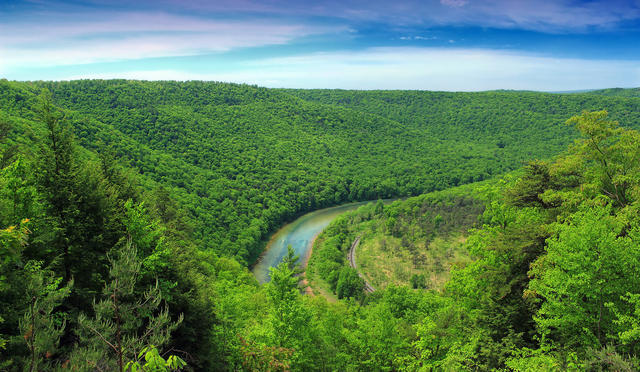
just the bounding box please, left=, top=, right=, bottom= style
left=71, top=241, right=182, bottom=372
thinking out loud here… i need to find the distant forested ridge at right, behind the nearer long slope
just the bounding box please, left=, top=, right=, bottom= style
left=284, top=89, right=639, bottom=139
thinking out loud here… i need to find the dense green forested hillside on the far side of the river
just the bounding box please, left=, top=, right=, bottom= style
left=0, top=80, right=640, bottom=263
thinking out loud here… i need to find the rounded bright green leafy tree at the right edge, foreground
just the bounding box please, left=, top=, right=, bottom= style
left=528, top=205, right=640, bottom=350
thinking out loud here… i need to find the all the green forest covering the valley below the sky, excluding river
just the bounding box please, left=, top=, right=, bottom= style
left=0, top=80, right=640, bottom=371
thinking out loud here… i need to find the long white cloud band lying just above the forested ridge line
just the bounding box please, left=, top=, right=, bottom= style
left=56, top=48, right=640, bottom=91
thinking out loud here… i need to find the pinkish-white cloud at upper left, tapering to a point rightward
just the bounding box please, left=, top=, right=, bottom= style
left=0, top=13, right=346, bottom=68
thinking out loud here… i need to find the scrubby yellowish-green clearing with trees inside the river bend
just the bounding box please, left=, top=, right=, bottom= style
left=310, top=190, right=483, bottom=292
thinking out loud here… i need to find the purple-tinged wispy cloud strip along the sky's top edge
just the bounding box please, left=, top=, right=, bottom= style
left=7, top=0, right=640, bottom=33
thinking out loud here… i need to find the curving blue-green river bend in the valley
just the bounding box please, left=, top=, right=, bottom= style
left=253, top=201, right=375, bottom=283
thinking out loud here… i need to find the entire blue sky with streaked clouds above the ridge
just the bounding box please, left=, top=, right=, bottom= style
left=0, top=0, right=640, bottom=91
